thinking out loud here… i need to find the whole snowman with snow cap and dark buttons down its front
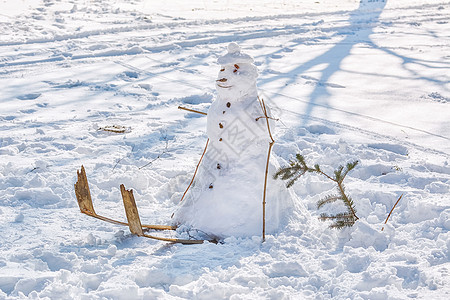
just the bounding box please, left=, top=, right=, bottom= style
left=173, top=43, right=295, bottom=238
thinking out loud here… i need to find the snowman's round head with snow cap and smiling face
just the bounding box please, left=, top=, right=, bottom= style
left=216, top=43, right=258, bottom=99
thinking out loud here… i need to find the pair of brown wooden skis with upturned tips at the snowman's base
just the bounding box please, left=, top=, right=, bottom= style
left=75, top=166, right=206, bottom=244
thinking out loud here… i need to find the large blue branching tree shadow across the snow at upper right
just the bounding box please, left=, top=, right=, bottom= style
left=259, top=0, right=448, bottom=126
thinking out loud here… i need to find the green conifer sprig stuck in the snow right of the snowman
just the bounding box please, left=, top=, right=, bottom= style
left=274, top=154, right=359, bottom=229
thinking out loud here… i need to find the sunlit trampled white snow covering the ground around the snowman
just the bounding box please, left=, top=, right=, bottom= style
left=0, top=0, right=450, bottom=299
